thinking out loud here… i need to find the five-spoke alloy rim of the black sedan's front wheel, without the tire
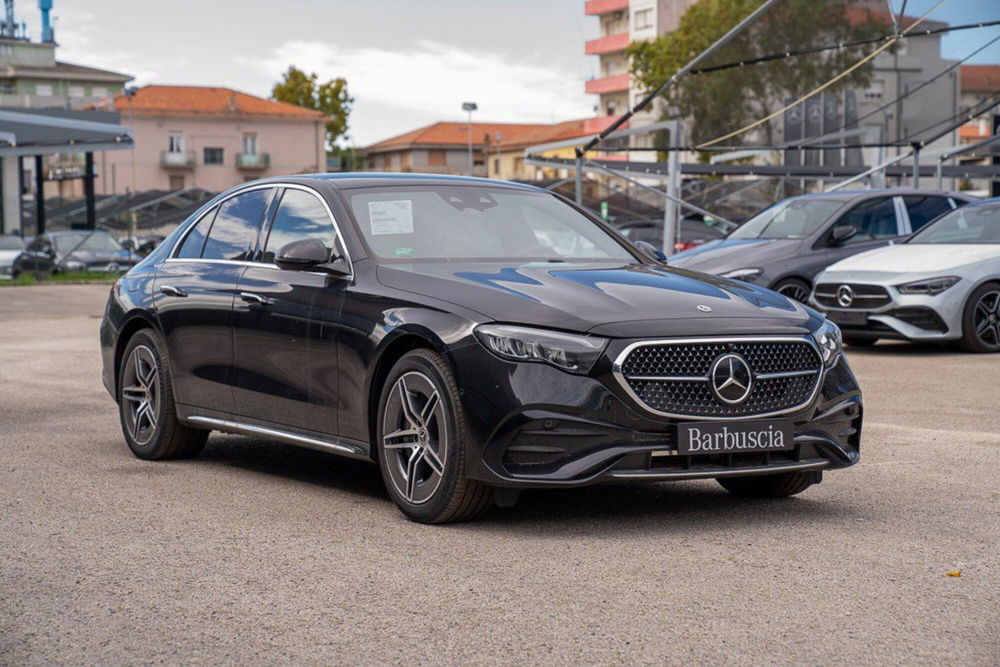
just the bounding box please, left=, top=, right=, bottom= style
left=382, top=371, right=448, bottom=505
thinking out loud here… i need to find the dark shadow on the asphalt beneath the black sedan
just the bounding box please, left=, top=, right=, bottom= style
left=193, top=436, right=872, bottom=536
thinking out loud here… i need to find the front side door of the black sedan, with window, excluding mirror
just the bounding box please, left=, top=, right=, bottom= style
left=233, top=185, right=346, bottom=435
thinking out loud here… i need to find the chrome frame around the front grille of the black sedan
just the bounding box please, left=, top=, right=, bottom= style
left=611, top=335, right=827, bottom=422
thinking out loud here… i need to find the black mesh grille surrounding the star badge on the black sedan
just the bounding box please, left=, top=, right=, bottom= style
left=618, top=339, right=822, bottom=418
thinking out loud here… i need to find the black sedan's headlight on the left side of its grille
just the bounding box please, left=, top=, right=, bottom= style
left=476, top=324, right=608, bottom=373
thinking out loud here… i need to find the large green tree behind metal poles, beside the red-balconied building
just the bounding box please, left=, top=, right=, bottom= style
left=628, top=0, right=890, bottom=143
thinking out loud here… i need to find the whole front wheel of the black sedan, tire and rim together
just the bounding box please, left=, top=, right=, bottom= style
left=376, top=349, right=493, bottom=523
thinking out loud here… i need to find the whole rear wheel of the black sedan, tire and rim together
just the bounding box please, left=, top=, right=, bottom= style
left=118, top=329, right=208, bottom=460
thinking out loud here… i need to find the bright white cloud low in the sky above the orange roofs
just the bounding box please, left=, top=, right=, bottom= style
left=236, top=40, right=593, bottom=143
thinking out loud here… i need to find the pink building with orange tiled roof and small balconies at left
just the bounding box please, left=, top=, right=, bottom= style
left=97, top=85, right=326, bottom=194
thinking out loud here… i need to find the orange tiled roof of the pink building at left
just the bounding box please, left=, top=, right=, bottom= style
left=106, top=85, right=326, bottom=120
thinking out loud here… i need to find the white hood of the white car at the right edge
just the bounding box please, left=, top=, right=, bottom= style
left=827, top=243, right=1000, bottom=273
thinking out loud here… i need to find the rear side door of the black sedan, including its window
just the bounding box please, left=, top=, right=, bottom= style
left=153, top=187, right=273, bottom=413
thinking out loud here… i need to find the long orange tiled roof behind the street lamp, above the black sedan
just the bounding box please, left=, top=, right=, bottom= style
left=365, top=119, right=587, bottom=153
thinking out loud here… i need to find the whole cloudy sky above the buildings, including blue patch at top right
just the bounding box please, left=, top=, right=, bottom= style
left=16, top=0, right=1000, bottom=145
